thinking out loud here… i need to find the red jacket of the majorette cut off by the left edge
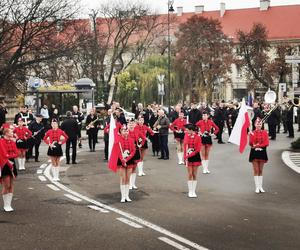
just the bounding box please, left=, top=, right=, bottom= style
left=0, top=138, right=19, bottom=169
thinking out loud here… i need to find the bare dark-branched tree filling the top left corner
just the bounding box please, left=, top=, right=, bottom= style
left=0, top=0, right=77, bottom=95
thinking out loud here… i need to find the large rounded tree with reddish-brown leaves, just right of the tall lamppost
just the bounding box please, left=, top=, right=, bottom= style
left=176, top=15, right=233, bottom=101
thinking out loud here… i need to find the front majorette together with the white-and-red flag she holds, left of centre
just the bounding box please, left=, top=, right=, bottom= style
left=108, top=114, right=135, bottom=203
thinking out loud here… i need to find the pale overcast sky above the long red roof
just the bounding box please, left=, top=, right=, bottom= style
left=80, top=0, right=300, bottom=13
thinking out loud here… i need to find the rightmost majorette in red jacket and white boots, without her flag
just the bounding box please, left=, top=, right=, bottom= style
left=249, top=118, right=269, bottom=193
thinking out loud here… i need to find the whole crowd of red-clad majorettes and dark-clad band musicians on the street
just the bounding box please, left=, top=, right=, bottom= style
left=0, top=98, right=300, bottom=211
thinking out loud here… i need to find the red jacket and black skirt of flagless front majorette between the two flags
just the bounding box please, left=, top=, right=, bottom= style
left=183, top=133, right=202, bottom=167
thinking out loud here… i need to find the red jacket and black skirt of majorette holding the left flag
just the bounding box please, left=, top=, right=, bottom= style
left=117, top=135, right=136, bottom=168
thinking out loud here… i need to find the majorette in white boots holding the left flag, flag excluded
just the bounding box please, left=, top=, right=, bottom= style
left=117, top=124, right=135, bottom=203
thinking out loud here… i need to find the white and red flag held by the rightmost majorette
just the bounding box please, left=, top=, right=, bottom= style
left=228, top=99, right=252, bottom=153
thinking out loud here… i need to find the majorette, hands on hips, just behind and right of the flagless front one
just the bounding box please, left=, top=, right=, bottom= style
left=196, top=112, right=219, bottom=174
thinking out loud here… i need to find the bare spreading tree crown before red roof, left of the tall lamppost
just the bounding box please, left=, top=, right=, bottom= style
left=74, top=2, right=164, bottom=102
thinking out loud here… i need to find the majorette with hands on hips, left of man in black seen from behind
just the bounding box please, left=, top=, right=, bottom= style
left=44, top=119, right=68, bottom=181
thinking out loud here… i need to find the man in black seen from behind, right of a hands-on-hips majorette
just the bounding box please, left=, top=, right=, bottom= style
left=61, top=111, right=79, bottom=164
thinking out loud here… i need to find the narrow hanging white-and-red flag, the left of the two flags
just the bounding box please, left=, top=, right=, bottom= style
left=108, top=114, right=120, bottom=172
